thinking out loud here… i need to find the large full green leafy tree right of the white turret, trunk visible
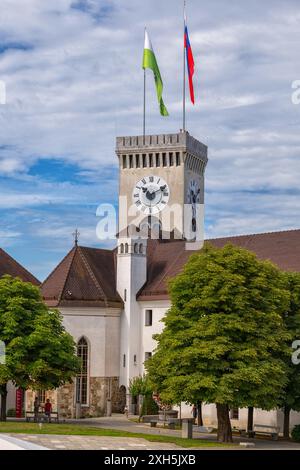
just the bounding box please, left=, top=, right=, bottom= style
left=146, top=245, right=290, bottom=442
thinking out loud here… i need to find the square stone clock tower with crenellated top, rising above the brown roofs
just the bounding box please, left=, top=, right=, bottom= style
left=116, top=132, right=207, bottom=240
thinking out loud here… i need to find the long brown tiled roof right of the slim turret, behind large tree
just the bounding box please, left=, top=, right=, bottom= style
left=138, top=230, right=300, bottom=300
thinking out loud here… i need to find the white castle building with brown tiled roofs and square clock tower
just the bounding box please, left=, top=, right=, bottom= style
left=31, top=132, right=300, bottom=427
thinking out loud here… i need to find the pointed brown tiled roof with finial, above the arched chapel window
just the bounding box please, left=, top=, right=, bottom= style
left=41, top=246, right=122, bottom=307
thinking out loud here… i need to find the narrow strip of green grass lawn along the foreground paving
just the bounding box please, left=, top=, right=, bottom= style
left=0, top=422, right=232, bottom=447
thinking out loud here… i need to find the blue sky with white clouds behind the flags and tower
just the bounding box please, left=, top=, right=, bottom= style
left=0, top=0, right=300, bottom=280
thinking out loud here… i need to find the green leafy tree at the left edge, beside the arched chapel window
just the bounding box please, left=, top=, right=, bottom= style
left=0, top=276, right=79, bottom=420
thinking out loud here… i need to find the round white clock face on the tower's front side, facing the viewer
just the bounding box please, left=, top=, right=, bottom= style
left=132, top=176, right=170, bottom=215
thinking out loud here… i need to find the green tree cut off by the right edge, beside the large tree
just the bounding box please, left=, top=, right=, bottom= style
left=279, top=273, right=300, bottom=439
